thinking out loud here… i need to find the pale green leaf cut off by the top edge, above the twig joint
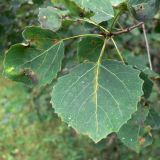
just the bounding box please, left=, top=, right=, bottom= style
left=72, top=0, right=114, bottom=23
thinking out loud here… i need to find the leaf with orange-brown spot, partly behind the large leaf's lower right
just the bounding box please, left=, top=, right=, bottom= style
left=117, top=105, right=152, bottom=152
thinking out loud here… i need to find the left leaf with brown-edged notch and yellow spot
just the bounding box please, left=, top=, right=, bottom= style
left=4, top=27, right=64, bottom=85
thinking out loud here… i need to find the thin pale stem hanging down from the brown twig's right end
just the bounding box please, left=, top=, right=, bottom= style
left=142, top=23, right=153, bottom=70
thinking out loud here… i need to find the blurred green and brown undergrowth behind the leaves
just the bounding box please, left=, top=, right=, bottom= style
left=0, top=0, right=160, bottom=160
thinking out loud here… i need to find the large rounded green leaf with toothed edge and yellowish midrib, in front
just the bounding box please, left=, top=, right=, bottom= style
left=52, top=61, right=143, bottom=142
